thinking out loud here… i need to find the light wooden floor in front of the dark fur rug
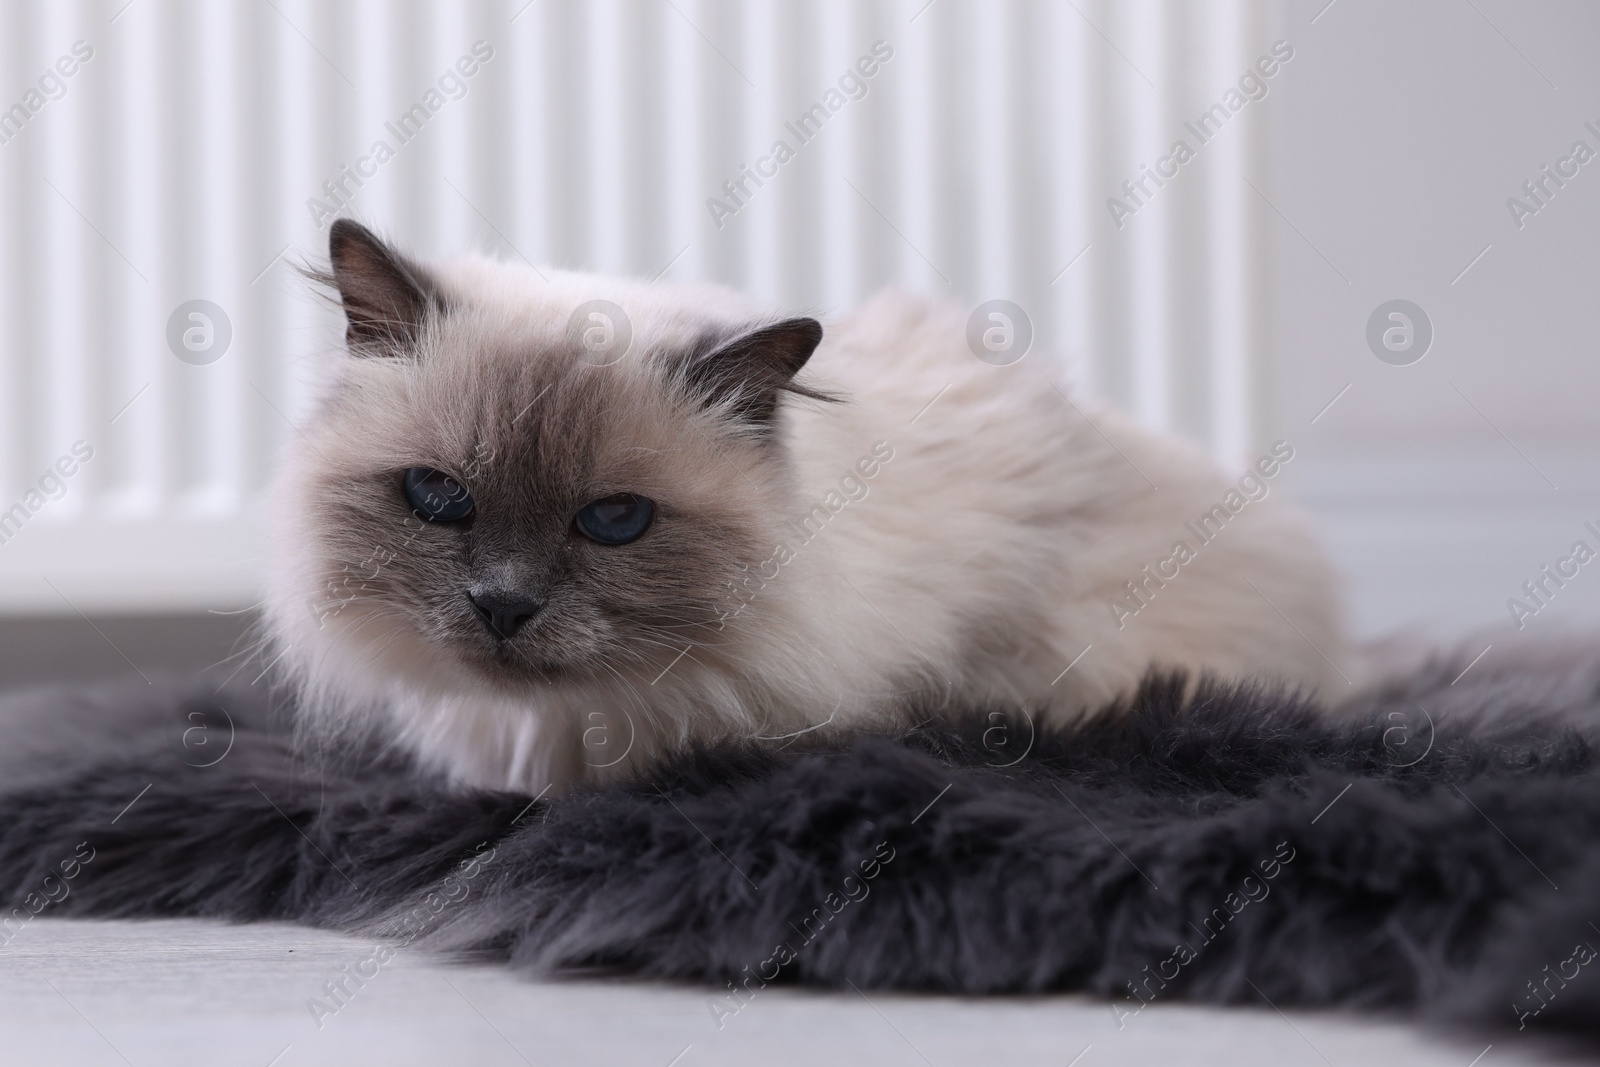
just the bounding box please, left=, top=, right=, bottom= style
left=0, top=917, right=1554, bottom=1067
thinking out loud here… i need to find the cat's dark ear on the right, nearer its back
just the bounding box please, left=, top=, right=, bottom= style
left=686, top=318, right=832, bottom=427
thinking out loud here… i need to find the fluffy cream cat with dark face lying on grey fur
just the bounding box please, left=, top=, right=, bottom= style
left=267, top=219, right=1346, bottom=792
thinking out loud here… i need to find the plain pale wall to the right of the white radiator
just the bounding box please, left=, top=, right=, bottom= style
left=1272, top=0, right=1600, bottom=648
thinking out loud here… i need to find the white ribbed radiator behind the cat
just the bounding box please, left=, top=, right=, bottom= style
left=0, top=0, right=1285, bottom=613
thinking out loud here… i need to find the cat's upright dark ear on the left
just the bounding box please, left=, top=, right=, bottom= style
left=328, top=219, right=445, bottom=355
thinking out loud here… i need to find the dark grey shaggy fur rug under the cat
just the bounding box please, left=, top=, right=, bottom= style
left=0, top=662, right=1600, bottom=1037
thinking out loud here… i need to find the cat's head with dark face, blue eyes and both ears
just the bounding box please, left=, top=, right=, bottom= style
left=274, top=222, right=821, bottom=691
